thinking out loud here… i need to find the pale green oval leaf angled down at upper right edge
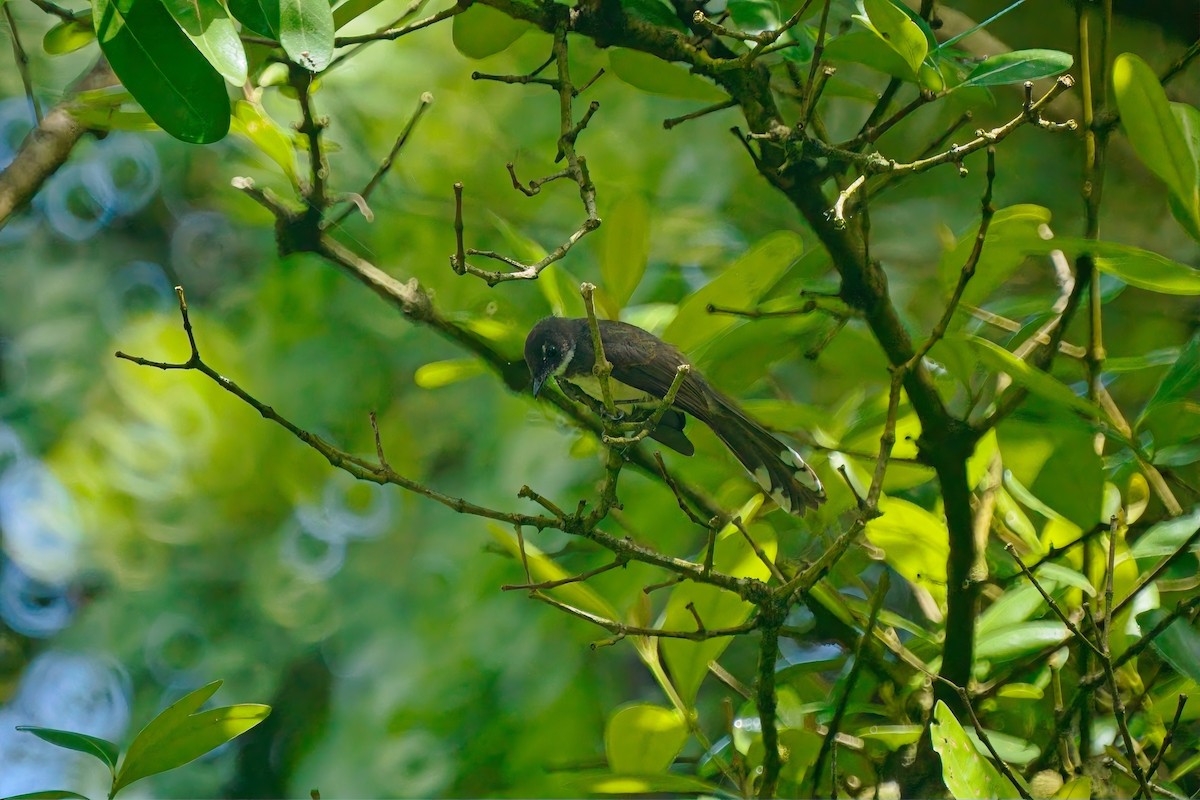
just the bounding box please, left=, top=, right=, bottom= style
left=1112, top=53, right=1200, bottom=210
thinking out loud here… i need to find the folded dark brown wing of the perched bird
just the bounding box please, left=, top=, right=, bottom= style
left=600, top=323, right=712, bottom=422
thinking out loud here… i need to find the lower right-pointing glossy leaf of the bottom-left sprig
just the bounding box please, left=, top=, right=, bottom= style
left=113, top=703, right=271, bottom=794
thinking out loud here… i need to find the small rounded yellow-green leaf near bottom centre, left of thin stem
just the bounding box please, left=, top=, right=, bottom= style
left=604, top=703, right=688, bottom=775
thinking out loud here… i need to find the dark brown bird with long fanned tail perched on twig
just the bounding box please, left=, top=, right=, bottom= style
left=524, top=317, right=826, bottom=517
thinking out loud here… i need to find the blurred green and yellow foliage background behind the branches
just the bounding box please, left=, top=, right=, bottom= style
left=0, top=0, right=1200, bottom=796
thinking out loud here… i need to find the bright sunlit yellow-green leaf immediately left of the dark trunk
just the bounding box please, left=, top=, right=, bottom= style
left=866, top=497, right=950, bottom=606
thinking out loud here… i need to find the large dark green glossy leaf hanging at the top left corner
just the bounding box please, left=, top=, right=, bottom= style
left=92, top=0, right=229, bottom=144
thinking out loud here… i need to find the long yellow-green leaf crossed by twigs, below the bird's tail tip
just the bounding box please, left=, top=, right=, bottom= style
left=659, top=494, right=779, bottom=708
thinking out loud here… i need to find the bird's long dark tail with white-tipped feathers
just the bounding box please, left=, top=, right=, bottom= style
left=710, top=409, right=826, bottom=517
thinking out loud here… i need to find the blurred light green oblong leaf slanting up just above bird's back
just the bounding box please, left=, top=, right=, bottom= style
left=662, top=230, right=804, bottom=357
